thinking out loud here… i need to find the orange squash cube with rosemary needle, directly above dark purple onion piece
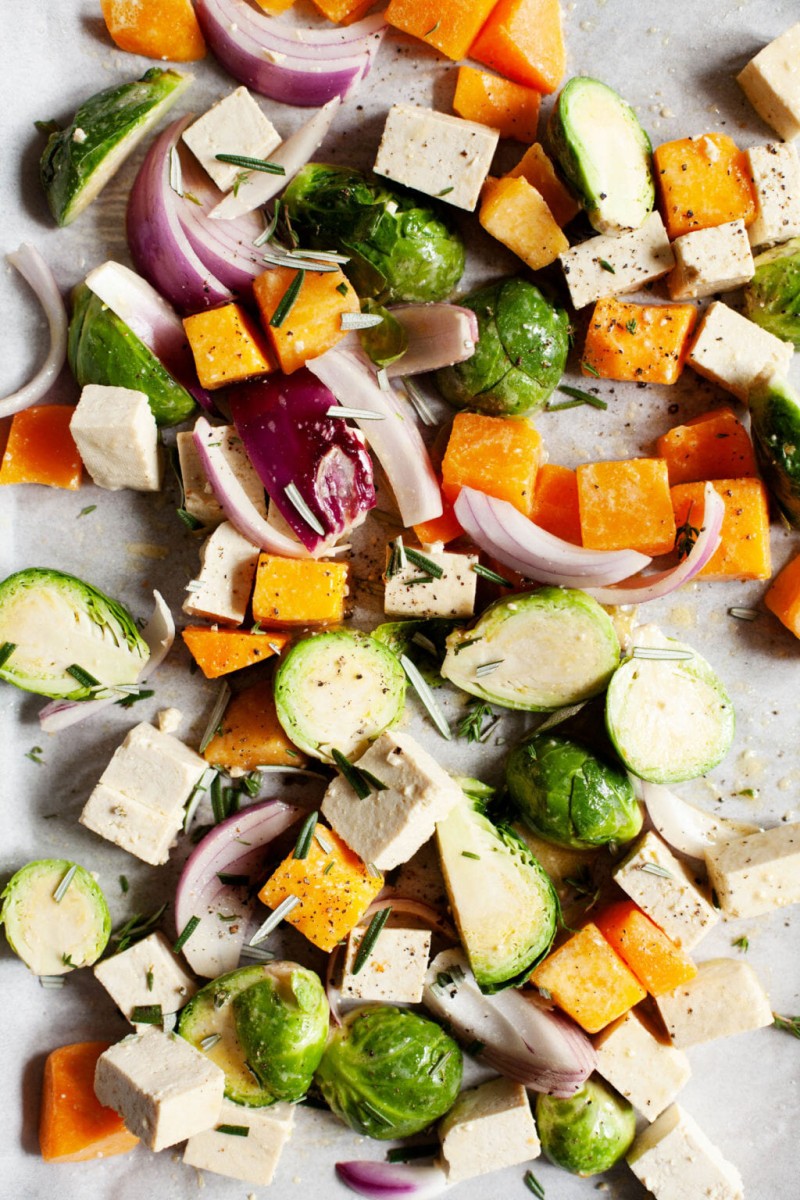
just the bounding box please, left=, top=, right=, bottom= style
left=253, top=266, right=361, bottom=374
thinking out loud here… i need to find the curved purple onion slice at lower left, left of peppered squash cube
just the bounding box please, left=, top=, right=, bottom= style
left=175, top=800, right=303, bottom=979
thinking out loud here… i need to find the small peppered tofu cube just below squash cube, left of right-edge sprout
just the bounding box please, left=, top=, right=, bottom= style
left=667, top=221, right=756, bottom=300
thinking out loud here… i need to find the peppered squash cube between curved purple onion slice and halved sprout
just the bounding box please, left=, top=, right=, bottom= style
left=258, top=829, right=384, bottom=950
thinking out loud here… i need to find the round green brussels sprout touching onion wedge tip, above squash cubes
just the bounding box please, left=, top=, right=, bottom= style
left=434, top=278, right=570, bottom=416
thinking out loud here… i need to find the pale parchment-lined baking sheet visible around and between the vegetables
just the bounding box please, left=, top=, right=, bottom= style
left=0, top=0, right=800, bottom=1200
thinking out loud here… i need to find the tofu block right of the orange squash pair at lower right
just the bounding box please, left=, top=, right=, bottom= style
left=656, top=959, right=774, bottom=1050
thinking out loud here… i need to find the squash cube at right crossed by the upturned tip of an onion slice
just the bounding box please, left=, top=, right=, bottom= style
left=672, top=479, right=772, bottom=580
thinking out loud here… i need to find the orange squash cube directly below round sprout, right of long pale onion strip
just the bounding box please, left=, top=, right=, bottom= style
left=441, top=413, right=542, bottom=516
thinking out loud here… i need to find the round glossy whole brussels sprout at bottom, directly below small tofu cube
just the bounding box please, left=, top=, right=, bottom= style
left=314, top=1004, right=462, bottom=1140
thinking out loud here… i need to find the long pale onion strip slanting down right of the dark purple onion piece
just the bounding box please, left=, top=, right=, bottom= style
left=306, top=335, right=441, bottom=526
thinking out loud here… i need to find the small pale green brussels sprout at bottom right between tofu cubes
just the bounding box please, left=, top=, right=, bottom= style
left=536, top=1075, right=636, bottom=1176
